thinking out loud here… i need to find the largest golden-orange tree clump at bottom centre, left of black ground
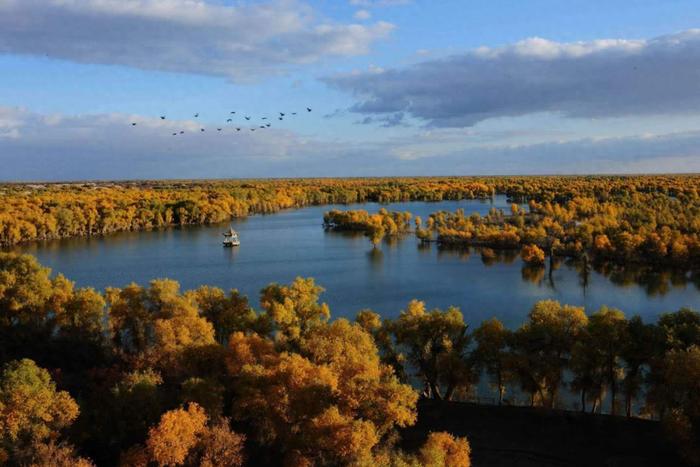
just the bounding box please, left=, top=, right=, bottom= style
left=228, top=319, right=417, bottom=465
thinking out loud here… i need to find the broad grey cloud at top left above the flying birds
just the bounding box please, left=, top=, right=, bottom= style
left=0, top=0, right=393, bottom=80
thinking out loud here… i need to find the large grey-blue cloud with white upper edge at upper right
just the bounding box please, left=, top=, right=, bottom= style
left=326, top=29, right=700, bottom=127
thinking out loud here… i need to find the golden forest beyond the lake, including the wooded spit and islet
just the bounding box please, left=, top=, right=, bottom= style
left=0, top=175, right=700, bottom=270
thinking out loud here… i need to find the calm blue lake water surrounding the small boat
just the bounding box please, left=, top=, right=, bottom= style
left=12, top=197, right=700, bottom=326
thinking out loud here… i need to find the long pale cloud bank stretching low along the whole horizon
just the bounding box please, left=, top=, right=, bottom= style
left=0, top=107, right=700, bottom=181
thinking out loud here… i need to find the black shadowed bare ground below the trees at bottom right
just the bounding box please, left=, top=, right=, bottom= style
left=402, top=400, right=682, bottom=467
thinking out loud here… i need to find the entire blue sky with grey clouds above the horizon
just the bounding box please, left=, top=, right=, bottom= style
left=0, top=0, right=700, bottom=181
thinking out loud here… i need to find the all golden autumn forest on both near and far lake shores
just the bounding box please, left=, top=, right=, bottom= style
left=0, top=175, right=700, bottom=467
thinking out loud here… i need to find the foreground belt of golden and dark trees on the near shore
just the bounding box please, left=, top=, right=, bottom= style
left=0, top=254, right=700, bottom=467
